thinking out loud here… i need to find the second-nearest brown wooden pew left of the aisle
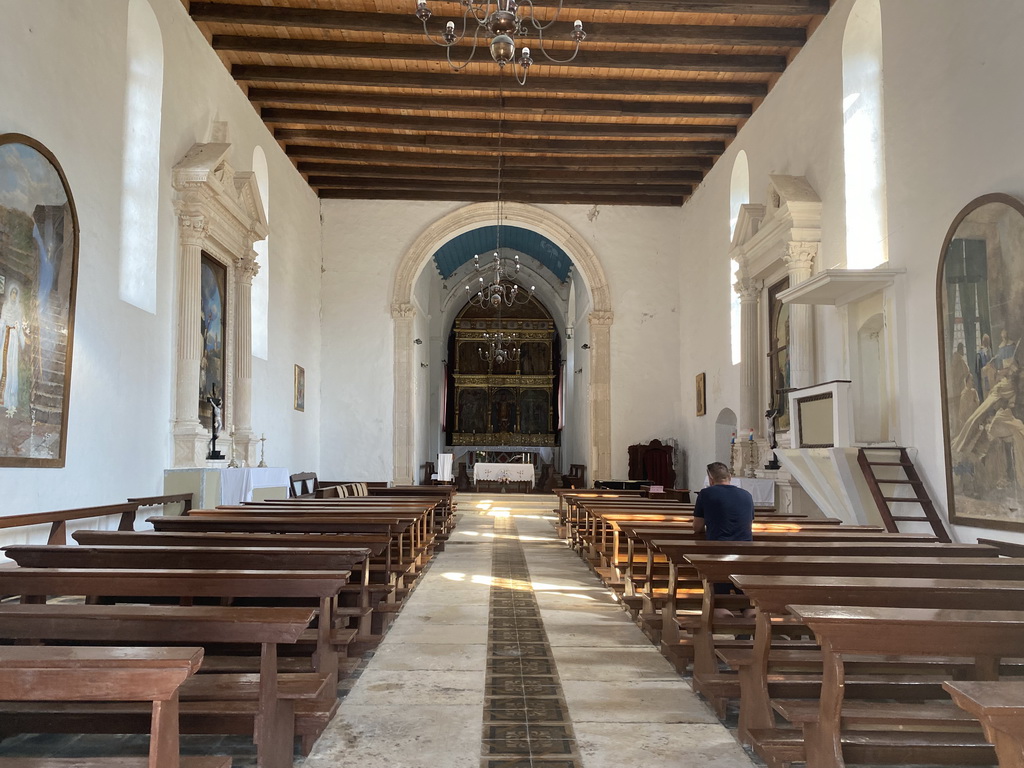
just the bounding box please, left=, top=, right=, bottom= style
left=0, top=603, right=319, bottom=768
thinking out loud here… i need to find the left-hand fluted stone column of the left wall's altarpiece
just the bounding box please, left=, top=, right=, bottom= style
left=174, top=213, right=210, bottom=467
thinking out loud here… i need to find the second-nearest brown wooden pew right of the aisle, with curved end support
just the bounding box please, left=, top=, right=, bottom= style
left=783, top=606, right=1024, bottom=768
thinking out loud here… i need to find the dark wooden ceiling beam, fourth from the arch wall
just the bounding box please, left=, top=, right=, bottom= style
left=285, top=144, right=715, bottom=172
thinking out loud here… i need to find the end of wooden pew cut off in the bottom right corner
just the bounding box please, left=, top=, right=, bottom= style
left=942, top=680, right=1024, bottom=768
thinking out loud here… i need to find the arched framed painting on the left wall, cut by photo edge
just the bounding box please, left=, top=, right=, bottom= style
left=0, top=133, right=79, bottom=467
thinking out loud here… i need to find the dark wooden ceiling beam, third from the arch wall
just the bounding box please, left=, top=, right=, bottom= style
left=298, top=161, right=705, bottom=185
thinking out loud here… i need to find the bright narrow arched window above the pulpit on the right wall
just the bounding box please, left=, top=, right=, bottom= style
left=843, top=0, right=889, bottom=269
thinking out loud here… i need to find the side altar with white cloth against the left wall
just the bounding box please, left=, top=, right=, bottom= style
left=164, top=467, right=289, bottom=509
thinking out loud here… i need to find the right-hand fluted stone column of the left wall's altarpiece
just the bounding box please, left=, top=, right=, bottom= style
left=234, top=251, right=259, bottom=467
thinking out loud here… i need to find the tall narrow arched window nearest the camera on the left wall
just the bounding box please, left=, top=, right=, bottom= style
left=120, top=0, right=164, bottom=312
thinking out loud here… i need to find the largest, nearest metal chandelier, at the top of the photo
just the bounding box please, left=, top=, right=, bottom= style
left=416, top=0, right=587, bottom=85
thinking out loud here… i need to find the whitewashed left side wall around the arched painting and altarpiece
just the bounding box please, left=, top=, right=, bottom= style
left=0, top=0, right=319, bottom=514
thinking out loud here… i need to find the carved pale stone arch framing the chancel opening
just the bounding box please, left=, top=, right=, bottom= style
left=391, top=203, right=613, bottom=483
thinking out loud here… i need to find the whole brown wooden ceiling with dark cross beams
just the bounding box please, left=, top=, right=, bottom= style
left=189, top=0, right=829, bottom=206
